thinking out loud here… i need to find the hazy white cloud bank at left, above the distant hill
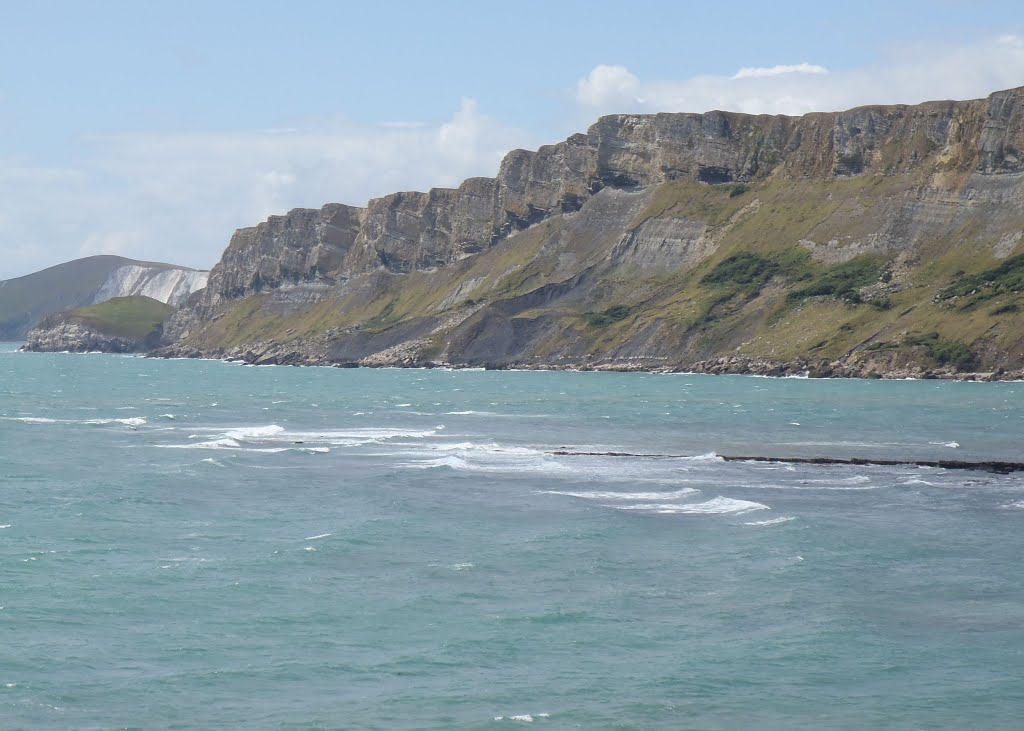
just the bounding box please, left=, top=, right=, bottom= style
left=0, top=99, right=538, bottom=280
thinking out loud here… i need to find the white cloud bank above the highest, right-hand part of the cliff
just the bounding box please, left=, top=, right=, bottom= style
left=573, top=34, right=1024, bottom=121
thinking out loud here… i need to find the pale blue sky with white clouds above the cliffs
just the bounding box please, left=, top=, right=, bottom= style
left=0, top=0, right=1024, bottom=280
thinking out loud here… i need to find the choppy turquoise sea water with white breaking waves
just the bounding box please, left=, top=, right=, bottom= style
left=0, top=345, right=1024, bottom=729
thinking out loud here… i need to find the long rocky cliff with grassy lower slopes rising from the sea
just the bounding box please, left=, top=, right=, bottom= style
left=158, top=89, right=1024, bottom=375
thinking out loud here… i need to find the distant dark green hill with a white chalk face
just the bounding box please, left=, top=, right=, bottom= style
left=0, top=255, right=208, bottom=341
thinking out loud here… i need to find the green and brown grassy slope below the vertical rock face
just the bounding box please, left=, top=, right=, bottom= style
left=180, top=174, right=1024, bottom=371
